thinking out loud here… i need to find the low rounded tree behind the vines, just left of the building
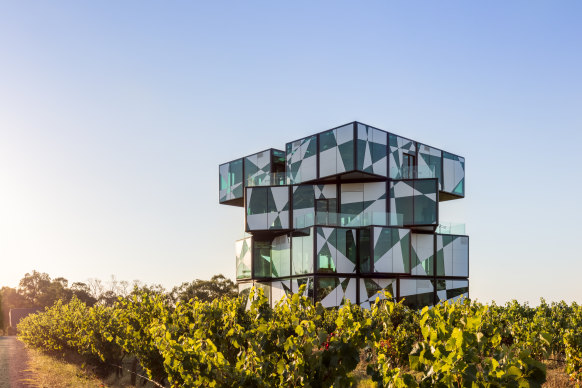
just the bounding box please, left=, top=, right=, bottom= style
left=171, top=275, right=238, bottom=303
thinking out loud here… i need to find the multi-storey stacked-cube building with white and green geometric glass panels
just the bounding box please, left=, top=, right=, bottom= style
left=219, top=122, right=469, bottom=308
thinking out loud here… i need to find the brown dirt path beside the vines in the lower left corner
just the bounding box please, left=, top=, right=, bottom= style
left=0, top=337, right=33, bottom=388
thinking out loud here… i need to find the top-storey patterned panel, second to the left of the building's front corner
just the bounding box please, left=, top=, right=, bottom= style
left=286, top=136, right=317, bottom=185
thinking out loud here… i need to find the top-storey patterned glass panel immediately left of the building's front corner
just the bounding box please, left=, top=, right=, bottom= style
left=319, top=124, right=354, bottom=178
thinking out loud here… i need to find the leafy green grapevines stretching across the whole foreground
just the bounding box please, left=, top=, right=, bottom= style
left=18, top=290, right=582, bottom=387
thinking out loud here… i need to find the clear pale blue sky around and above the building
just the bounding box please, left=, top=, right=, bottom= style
left=0, top=1, right=582, bottom=303
